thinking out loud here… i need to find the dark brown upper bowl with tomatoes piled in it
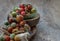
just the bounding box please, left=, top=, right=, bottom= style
left=25, top=14, right=40, bottom=27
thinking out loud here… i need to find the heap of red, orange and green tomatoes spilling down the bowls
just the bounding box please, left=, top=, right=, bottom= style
left=0, top=4, right=36, bottom=41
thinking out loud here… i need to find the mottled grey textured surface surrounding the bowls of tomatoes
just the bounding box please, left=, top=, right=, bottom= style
left=0, top=0, right=60, bottom=41
